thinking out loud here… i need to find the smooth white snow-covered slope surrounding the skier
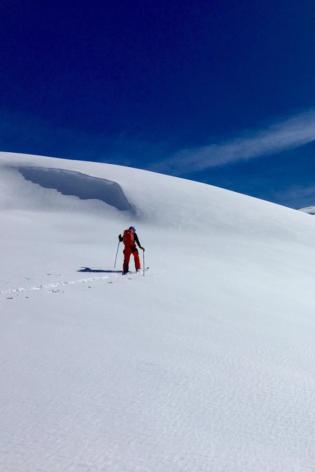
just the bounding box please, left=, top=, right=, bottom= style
left=0, top=153, right=315, bottom=472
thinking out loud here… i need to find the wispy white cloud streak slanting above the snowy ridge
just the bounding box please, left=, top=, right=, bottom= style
left=153, top=109, right=315, bottom=175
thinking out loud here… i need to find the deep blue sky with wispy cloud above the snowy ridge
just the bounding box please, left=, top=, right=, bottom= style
left=0, top=0, right=315, bottom=208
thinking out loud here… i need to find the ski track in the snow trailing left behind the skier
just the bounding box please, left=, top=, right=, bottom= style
left=0, top=272, right=142, bottom=300
